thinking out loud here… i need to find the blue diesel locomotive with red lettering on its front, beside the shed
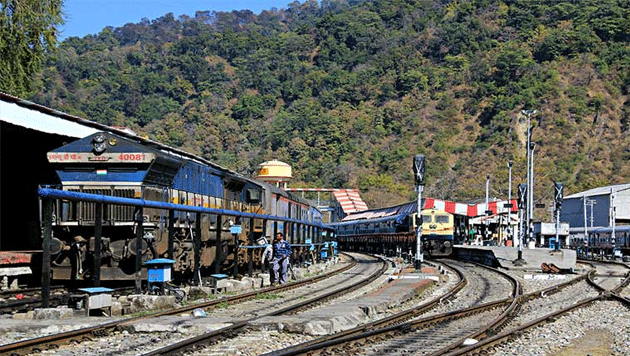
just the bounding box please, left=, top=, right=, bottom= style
left=48, top=132, right=322, bottom=280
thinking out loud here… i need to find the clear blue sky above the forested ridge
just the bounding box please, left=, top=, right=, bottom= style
left=59, top=0, right=296, bottom=40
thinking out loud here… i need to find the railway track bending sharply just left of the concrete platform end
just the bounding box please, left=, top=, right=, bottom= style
left=252, top=261, right=520, bottom=355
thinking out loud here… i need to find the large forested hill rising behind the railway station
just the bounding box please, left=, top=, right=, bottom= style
left=31, top=0, right=630, bottom=214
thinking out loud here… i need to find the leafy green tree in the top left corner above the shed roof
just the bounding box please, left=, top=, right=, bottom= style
left=0, top=0, right=63, bottom=96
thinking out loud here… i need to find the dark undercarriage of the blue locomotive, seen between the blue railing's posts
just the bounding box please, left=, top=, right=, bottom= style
left=51, top=219, right=259, bottom=280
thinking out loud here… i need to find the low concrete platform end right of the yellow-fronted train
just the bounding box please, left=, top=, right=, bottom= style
left=453, top=245, right=577, bottom=270
